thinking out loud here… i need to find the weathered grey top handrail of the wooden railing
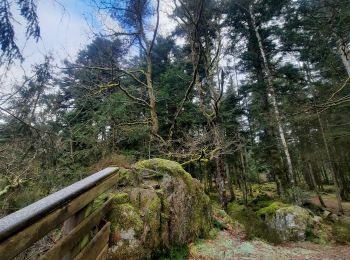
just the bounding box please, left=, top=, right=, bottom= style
left=0, top=167, right=118, bottom=241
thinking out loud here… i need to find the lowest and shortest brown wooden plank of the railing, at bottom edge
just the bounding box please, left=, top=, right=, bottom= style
left=74, top=222, right=111, bottom=260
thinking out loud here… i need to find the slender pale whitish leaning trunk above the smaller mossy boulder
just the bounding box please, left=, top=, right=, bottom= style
left=249, top=5, right=297, bottom=194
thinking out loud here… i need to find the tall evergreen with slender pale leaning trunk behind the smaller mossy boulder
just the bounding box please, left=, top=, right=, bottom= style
left=226, top=1, right=295, bottom=199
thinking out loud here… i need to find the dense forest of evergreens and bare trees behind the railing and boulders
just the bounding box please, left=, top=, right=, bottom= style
left=0, top=0, right=350, bottom=259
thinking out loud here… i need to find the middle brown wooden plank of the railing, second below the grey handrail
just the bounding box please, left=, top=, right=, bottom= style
left=41, top=198, right=113, bottom=260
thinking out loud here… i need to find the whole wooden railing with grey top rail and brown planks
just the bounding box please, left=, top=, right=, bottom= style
left=0, top=167, right=118, bottom=260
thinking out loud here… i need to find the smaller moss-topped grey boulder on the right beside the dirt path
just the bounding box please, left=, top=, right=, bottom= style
left=257, top=202, right=313, bottom=241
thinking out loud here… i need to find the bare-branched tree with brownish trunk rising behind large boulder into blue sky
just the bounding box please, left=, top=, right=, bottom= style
left=95, top=0, right=163, bottom=140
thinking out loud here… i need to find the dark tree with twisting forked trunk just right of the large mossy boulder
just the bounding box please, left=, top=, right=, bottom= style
left=175, top=0, right=227, bottom=208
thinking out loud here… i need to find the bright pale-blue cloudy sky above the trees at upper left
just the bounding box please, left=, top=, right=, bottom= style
left=0, top=0, right=176, bottom=94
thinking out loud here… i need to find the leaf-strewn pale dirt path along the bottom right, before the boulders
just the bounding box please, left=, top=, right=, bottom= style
left=190, top=229, right=350, bottom=260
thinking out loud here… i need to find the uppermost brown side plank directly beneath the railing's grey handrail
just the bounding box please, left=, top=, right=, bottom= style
left=0, top=174, right=119, bottom=259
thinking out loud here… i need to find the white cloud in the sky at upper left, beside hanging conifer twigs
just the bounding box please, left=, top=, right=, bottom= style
left=0, top=1, right=91, bottom=92
